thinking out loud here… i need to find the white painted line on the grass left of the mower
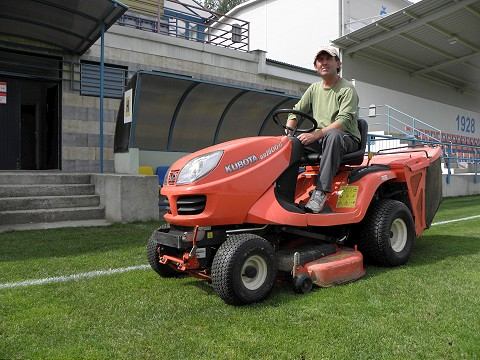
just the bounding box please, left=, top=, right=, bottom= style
left=0, top=265, right=150, bottom=290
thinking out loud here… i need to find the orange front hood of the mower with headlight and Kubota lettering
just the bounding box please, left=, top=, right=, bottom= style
left=161, top=136, right=292, bottom=226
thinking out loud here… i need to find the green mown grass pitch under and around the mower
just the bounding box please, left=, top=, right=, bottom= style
left=0, top=196, right=480, bottom=359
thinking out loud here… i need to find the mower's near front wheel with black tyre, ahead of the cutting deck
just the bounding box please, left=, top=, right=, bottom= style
left=211, top=234, right=277, bottom=305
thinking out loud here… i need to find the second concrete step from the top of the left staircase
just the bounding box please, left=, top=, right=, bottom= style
left=0, top=184, right=95, bottom=198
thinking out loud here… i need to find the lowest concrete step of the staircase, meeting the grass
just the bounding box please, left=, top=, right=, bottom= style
left=0, top=206, right=105, bottom=225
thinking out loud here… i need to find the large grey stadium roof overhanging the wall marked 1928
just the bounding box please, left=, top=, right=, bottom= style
left=333, top=0, right=480, bottom=94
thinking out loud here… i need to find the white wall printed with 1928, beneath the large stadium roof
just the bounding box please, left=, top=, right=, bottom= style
left=343, top=56, right=480, bottom=138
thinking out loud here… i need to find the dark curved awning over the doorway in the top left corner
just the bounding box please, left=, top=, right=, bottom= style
left=0, top=0, right=127, bottom=55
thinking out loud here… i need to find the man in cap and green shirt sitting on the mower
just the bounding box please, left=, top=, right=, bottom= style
left=286, top=46, right=361, bottom=214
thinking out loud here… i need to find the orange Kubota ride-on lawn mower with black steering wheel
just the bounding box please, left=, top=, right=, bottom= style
left=147, top=109, right=442, bottom=305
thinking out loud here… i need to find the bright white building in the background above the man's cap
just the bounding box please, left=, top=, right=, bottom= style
left=228, top=0, right=408, bottom=69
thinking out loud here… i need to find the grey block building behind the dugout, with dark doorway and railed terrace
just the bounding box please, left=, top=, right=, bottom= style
left=0, top=0, right=312, bottom=172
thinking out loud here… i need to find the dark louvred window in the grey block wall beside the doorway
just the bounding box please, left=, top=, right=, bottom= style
left=80, top=61, right=128, bottom=99
